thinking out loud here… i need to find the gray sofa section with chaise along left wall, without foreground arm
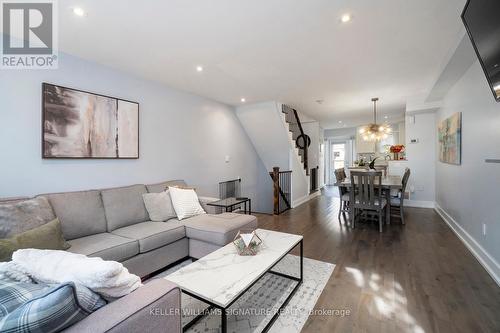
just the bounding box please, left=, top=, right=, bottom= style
left=43, top=180, right=257, bottom=277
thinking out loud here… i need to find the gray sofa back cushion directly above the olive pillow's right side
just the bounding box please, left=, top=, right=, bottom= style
left=48, top=191, right=106, bottom=239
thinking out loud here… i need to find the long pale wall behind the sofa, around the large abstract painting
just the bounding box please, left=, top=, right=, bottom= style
left=0, top=54, right=272, bottom=211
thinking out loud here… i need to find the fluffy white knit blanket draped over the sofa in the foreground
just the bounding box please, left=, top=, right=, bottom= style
left=12, top=249, right=142, bottom=299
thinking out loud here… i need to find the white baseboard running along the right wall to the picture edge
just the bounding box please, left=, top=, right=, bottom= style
left=434, top=203, right=500, bottom=286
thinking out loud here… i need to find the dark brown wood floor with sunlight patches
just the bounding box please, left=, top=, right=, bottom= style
left=258, top=190, right=500, bottom=332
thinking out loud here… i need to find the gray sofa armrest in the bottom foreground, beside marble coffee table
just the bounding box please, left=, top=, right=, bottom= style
left=64, top=279, right=182, bottom=333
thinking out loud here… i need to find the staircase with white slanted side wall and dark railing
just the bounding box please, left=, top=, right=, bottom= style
left=235, top=101, right=311, bottom=208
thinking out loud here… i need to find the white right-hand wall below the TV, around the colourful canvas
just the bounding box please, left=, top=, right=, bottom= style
left=436, top=59, right=500, bottom=283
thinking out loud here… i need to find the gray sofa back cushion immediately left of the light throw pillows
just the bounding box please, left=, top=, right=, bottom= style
left=101, top=185, right=149, bottom=231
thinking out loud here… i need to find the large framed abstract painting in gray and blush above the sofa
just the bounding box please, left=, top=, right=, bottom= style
left=42, top=83, right=139, bottom=159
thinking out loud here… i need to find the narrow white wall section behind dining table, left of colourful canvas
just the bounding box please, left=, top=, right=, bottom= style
left=405, top=113, right=437, bottom=207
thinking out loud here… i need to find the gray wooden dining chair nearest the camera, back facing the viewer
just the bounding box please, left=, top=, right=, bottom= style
left=350, top=171, right=387, bottom=232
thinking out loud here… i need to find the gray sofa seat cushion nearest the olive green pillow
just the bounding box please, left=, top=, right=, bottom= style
left=68, top=233, right=139, bottom=261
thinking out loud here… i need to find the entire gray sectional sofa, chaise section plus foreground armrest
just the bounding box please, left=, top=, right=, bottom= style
left=3, top=180, right=257, bottom=333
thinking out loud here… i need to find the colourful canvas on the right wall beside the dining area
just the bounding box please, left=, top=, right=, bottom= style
left=438, top=112, right=462, bottom=165
